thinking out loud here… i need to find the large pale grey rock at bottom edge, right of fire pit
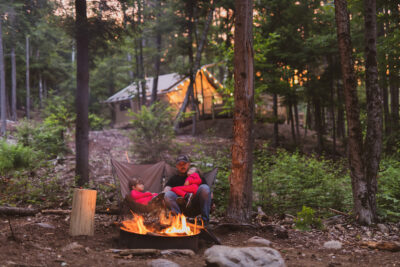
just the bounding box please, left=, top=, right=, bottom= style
left=204, top=245, right=285, bottom=267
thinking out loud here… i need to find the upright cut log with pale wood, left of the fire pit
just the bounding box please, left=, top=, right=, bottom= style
left=69, top=189, right=97, bottom=236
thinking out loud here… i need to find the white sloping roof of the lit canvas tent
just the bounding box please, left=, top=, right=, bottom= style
left=105, top=73, right=183, bottom=103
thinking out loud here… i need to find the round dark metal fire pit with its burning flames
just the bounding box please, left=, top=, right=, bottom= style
left=119, top=214, right=202, bottom=251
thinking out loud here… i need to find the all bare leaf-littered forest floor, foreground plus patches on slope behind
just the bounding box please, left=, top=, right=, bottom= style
left=0, top=122, right=400, bottom=266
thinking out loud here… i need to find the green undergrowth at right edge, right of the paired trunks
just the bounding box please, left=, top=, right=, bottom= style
left=376, top=158, right=400, bottom=221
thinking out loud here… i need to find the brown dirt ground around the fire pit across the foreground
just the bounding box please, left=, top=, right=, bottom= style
left=0, top=214, right=400, bottom=266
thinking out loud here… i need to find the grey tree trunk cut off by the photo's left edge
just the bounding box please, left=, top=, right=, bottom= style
left=0, top=17, right=7, bottom=136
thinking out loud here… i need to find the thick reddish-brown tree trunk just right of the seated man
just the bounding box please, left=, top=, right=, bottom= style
left=227, top=0, right=254, bottom=222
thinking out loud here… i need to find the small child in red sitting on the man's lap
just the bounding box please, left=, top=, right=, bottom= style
left=171, top=167, right=202, bottom=207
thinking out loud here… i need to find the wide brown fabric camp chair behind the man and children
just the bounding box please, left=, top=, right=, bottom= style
left=111, top=159, right=218, bottom=216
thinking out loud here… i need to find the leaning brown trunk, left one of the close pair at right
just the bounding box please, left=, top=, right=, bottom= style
left=335, top=0, right=374, bottom=224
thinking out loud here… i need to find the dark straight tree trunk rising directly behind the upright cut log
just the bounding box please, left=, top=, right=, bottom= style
left=75, top=0, right=89, bottom=186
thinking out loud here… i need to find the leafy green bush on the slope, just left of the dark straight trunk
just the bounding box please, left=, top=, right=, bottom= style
left=16, top=121, right=67, bottom=158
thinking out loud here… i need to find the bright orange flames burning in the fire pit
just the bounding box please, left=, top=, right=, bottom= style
left=121, top=213, right=203, bottom=236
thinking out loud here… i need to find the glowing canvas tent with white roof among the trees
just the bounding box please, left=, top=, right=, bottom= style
left=105, top=66, right=222, bottom=127
